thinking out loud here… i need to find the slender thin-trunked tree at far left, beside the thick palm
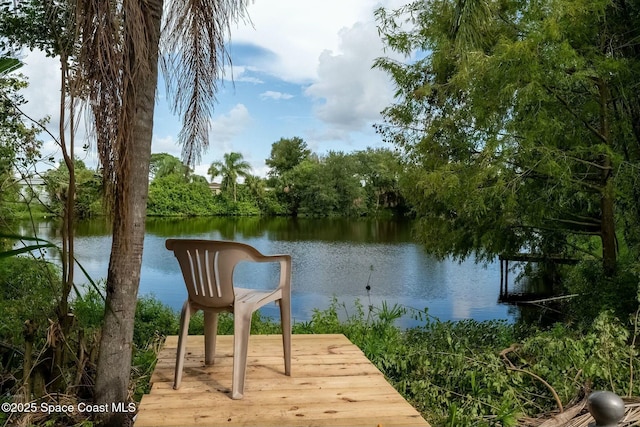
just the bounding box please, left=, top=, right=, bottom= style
left=0, top=0, right=90, bottom=402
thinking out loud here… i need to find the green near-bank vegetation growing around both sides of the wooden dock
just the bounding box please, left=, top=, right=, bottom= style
left=0, top=276, right=640, bottom=426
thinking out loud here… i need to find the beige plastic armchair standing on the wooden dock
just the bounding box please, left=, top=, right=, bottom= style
left=166, top=239, right=291, bottom=399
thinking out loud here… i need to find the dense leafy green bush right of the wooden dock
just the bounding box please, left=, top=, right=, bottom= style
left=378, top=312, right=640, bottom=426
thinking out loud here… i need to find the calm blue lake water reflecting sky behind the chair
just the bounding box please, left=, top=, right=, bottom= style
left=15, top=218, right=516, bottom=327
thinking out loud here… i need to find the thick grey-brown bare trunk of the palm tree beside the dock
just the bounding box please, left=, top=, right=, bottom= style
left=95, top=0, right=163, bottom=426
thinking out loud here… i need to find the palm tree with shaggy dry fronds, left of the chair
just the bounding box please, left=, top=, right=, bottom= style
left=75, top=0, right=247, bottom=426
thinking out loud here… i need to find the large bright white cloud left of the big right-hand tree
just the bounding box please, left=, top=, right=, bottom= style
left=226, top=0, right=407, bottom=139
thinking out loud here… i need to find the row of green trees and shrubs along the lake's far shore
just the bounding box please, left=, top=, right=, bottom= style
left=3, top=146, right=409, bottom=219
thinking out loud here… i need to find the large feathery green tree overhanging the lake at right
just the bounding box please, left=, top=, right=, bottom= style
left=376, top=0, right=640, bottom=275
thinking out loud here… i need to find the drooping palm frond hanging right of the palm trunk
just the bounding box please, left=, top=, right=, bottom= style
left=160, top=0, right=247, bottom=166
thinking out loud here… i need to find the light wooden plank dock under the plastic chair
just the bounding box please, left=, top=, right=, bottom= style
left=135, top=335, right=429, bottom=427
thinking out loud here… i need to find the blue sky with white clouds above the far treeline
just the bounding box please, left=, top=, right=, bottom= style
left=20, top=0, right=409, bottom=180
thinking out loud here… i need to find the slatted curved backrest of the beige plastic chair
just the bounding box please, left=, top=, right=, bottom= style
left=165, top=239, right=257, bottom=308
